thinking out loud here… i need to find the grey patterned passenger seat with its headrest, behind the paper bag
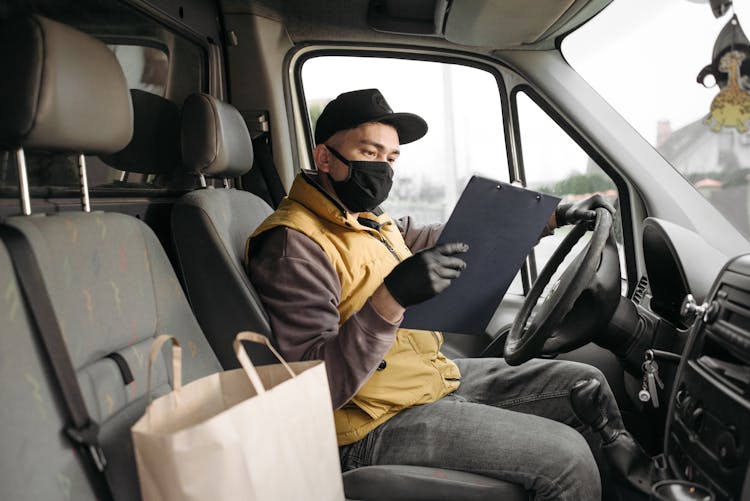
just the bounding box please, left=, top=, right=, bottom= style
left=0, top=17, right=220, bottom=500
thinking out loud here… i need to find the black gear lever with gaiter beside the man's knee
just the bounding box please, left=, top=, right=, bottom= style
left=570, top=379, right=652, bottom=495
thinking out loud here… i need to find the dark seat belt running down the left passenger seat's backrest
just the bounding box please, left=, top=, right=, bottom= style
left=0, top=226, right=113, bottom=500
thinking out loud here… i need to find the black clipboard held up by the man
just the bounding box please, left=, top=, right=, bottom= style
left=401, top=176, right=560, bottom=335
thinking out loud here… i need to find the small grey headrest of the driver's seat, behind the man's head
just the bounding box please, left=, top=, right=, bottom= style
left=181, top=94, right=253, bottom=178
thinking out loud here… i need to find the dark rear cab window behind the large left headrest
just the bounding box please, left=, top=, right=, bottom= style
left=0, top=0, right=207, bottom=198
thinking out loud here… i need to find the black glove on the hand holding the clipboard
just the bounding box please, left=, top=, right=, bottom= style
left=383, top=242, right=469, bottom=308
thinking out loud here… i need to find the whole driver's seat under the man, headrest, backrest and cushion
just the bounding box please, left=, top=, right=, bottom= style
left=172, top=94, right=530, bottom=501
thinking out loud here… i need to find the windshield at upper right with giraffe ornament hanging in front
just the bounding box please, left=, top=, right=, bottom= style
left=562, top=0, right=750, bottom=240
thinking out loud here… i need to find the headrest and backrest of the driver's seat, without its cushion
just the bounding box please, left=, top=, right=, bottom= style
left=172, top=94, right=276, bottom=369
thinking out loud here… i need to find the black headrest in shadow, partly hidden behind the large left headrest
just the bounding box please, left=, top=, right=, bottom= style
left=102, top=89, right=180, bottom=174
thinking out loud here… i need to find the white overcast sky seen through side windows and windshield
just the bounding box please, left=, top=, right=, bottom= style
left=303, top=0, right=750, bottom=188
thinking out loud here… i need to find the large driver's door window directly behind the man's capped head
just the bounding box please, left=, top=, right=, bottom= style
left=302, top=56, right=508, bottom=224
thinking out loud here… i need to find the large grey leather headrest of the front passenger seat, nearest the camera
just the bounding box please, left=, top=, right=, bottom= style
left=0, top=16, right=133, bottom=153
